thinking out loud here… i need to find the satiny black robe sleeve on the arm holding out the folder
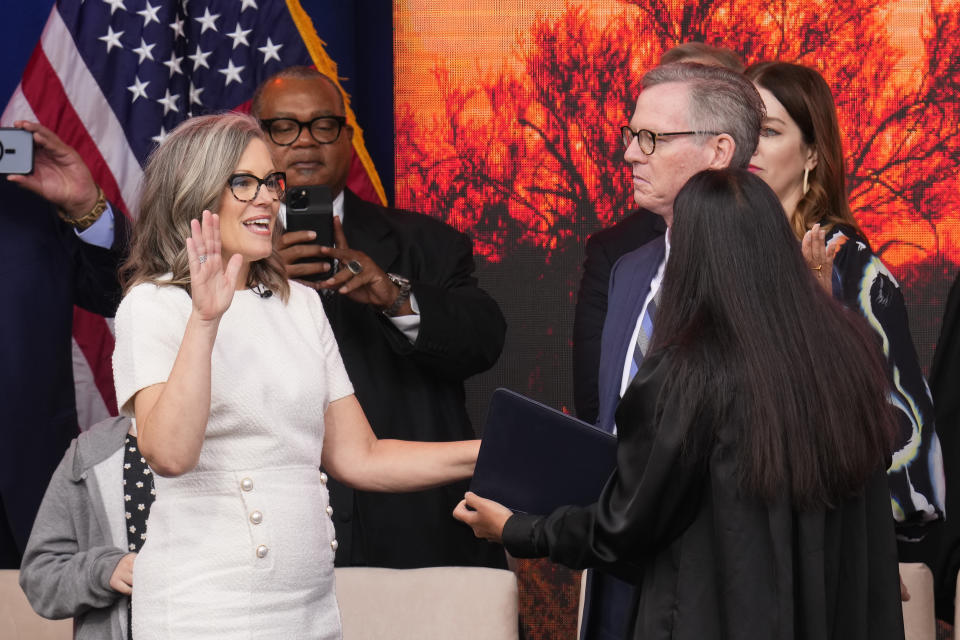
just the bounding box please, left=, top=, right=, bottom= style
left=503, top=357, right=703, bottom=580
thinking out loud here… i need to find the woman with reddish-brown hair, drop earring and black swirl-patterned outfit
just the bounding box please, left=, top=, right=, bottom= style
left=746, top=62, right=944, bottom=539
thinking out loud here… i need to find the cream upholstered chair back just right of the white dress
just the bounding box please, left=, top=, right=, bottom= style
left=336, top=567, right=518, bottom=640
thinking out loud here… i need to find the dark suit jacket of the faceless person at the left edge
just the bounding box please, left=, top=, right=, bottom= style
left=0, top=179, right=129, bottom=553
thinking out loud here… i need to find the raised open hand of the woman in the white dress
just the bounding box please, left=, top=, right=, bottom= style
left=187, top=210, right=243, bottom=321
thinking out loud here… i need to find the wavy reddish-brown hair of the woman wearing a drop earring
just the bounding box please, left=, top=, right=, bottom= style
left=746, top=62, right=864, bottom=239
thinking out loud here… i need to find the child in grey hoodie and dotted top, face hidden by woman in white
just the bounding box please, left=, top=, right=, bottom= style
left=20, top=418, right=153, bottom=640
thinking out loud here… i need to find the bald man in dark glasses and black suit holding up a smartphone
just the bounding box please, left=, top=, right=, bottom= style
left=252, top=67, right=506, bottom=568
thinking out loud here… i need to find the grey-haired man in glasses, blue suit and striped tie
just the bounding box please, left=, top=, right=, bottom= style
left=581, top=64, right=764, bottom=640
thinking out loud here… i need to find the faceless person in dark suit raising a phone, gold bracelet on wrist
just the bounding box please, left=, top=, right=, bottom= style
left=0, top=120, right=129, bottom=569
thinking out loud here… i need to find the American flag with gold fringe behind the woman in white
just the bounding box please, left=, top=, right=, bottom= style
left=0, top=0, right=385, bottom=428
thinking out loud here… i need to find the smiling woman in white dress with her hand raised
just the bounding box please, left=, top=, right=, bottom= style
left=113, top=114, right=478, bottom=640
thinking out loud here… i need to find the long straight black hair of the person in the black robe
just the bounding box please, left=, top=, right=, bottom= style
left=653, top=169, right=895, bottom=508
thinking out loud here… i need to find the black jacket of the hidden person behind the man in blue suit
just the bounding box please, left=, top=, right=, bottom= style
left=573, top=209, right=667, bottom=423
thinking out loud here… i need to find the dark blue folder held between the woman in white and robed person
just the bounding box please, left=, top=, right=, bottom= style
left=470, top=389, right=617, bottom=514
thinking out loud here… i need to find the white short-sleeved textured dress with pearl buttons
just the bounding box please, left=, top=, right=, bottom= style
left=113, top=282, right=353, bottom=640
